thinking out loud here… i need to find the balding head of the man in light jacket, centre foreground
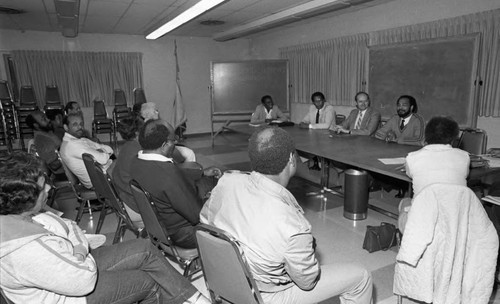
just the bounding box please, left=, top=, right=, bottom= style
left=248, top=127, right=296, bottom=177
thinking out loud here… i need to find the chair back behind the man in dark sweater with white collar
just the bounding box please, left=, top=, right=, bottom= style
left=130, top=180, right=172, bottom=247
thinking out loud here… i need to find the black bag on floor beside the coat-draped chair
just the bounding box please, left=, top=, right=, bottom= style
left=363, top=222, right=401, bottom=253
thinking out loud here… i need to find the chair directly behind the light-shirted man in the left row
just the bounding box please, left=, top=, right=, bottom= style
left=56, top=150, right=101, bottom=229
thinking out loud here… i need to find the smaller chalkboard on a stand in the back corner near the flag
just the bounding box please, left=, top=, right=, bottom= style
left=211, top=60, right=290, bottom=115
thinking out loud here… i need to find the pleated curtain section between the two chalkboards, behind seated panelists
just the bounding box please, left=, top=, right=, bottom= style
left=280, top=34, right=368, bottom=105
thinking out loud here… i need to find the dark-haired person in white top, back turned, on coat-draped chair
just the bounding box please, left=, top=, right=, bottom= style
left=399, top=116, right=470, bottom=231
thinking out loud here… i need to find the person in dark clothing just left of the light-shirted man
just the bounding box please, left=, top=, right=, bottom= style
left=26, top=111, right=64, bottom=174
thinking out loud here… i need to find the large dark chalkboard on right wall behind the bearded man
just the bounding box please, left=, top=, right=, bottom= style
left=368, top=34, right=479, bottom=127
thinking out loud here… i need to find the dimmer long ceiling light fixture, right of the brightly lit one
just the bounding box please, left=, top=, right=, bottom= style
left=213, top=0, right=350, bottom=41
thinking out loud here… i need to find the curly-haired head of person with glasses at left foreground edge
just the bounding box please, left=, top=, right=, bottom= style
left=0, top=152, right=50, bottom=215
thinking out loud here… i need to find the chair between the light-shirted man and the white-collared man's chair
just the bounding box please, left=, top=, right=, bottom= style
left=82, top=153, right=142, bottom=244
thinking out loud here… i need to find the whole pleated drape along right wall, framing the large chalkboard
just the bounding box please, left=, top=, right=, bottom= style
left=280, top=9, right=500, bottom=117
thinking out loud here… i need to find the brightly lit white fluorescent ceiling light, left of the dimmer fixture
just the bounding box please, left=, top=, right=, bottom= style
left=146, top=0, right=227, bottom=40
